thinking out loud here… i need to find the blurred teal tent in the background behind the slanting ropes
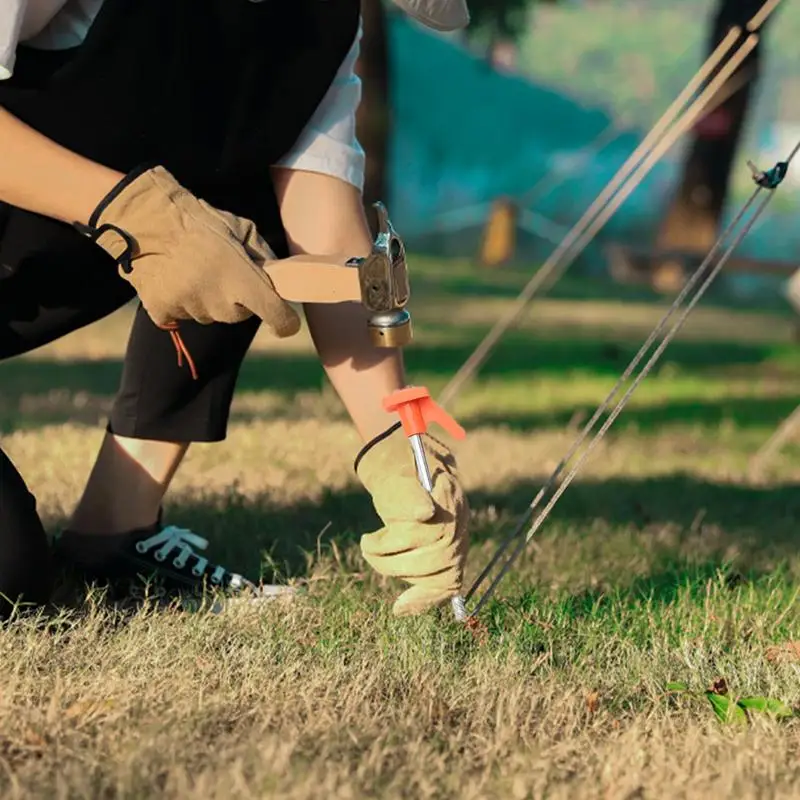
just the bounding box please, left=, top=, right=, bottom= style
left=388, top=7, right=800, bottom=287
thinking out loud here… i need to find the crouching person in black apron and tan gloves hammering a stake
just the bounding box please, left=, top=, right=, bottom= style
left=0, top=0, right=469, bottom=614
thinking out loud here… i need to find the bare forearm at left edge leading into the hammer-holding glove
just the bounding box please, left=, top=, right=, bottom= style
left=0, top=107, right=124, bottom=223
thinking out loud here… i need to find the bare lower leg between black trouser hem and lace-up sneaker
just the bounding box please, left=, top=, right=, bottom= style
left=68, top=433, right=189, bottom=534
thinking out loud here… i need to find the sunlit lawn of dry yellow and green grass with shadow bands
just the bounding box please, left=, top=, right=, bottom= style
left=0, top=260, right=800, bottom=800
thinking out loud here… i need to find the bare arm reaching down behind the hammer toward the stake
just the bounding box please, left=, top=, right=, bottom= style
left=275, top=170, right=405, bottom=441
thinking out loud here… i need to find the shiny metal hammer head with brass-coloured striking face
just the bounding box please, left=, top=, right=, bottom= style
left=351, top=203, right=412, bottom=347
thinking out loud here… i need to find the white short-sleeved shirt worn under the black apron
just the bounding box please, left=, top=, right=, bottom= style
left=0, top=0, right=365, bottom=190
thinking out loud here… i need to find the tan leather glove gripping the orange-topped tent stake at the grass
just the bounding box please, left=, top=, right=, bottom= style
left=355, top=425, right=469, bottom=616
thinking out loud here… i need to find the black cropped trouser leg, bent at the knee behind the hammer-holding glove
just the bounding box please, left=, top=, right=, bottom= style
left=0, top=204, right=260, bottom=442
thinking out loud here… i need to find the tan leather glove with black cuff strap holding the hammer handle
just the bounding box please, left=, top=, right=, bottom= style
left=76, top=167, right=300, bottom=338
